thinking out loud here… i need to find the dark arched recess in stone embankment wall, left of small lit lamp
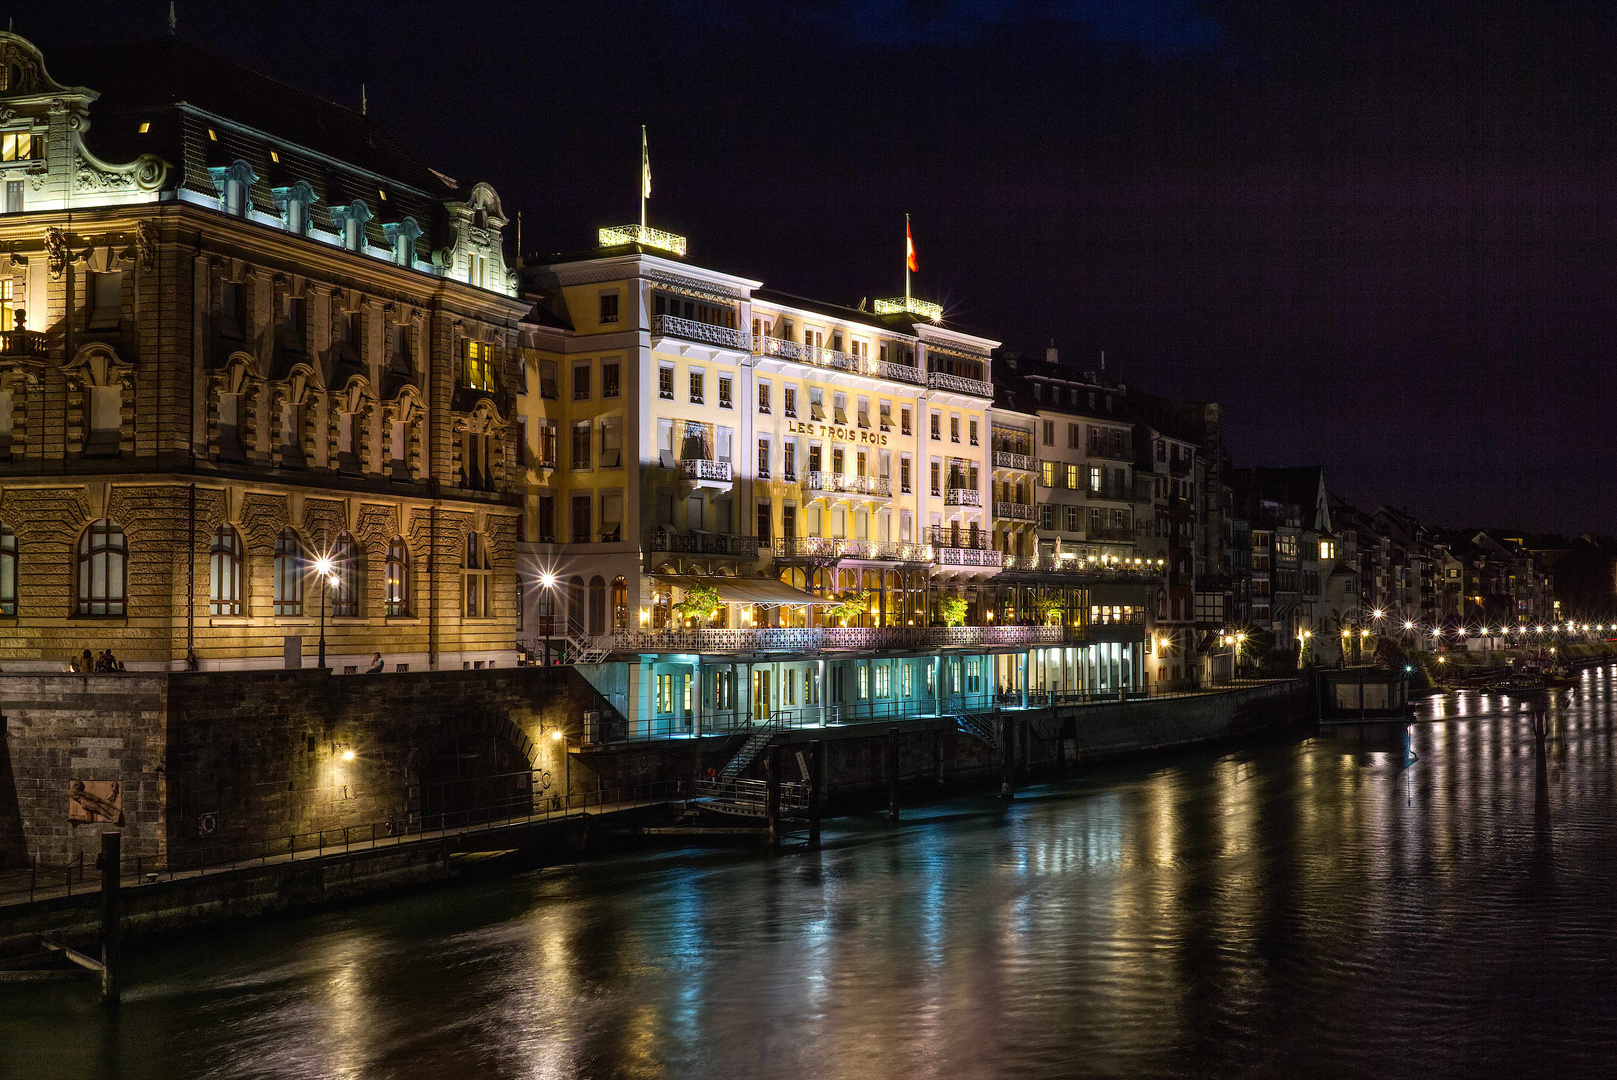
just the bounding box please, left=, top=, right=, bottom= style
left=409, top=723, right=545, bottom=828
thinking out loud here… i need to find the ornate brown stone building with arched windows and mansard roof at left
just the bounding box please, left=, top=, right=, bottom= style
left=0, top=34, right=527, bottom=671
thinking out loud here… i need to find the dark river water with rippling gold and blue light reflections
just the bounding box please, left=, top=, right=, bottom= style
left=9, top=669, right=1617, bottom=1080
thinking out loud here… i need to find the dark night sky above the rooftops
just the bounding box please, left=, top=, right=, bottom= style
left=25, top=0, right=1617, bottom=532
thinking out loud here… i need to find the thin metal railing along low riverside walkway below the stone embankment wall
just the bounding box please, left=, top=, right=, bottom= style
left=0, top=781, right=692, bottom=904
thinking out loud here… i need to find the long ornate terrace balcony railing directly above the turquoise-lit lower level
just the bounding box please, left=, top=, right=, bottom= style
left=613, top=626, right=1060, bottom=653
